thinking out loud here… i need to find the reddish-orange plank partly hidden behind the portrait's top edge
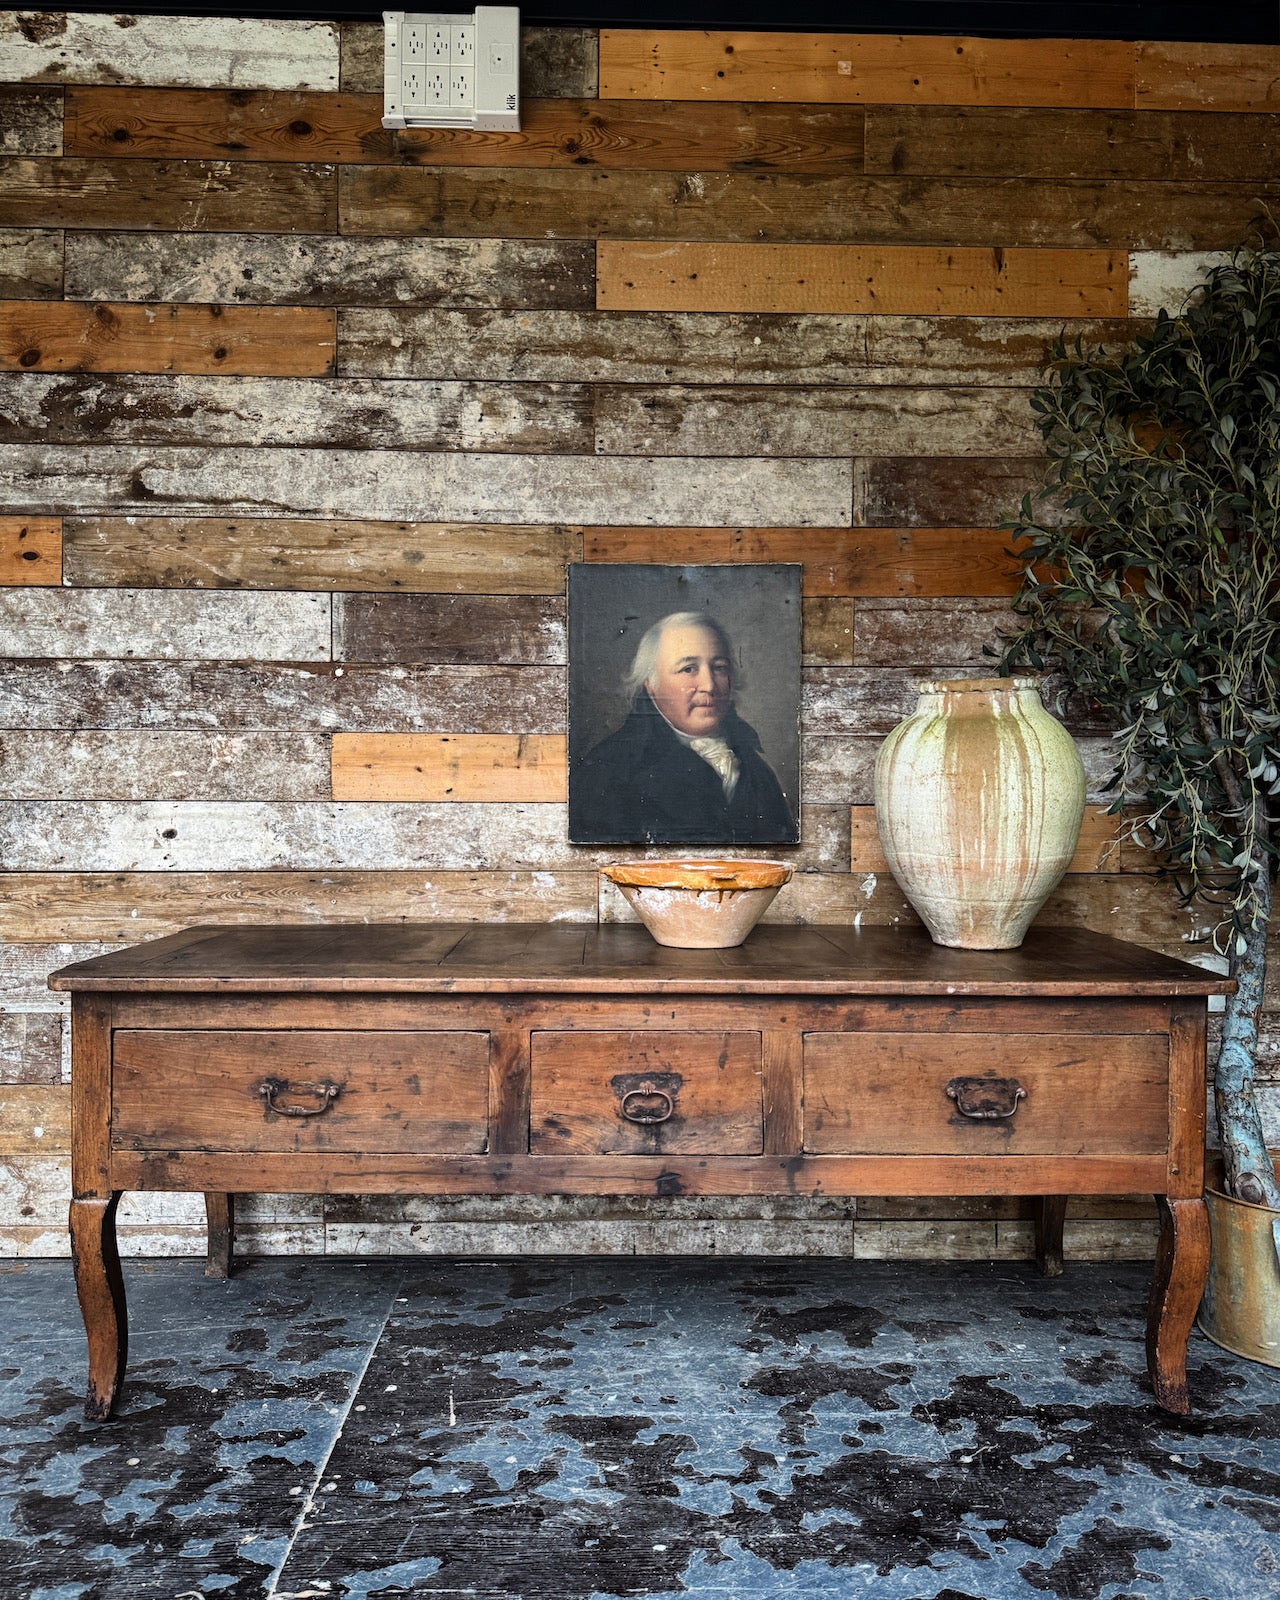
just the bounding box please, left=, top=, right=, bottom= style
left=582, top=528, right=1019, bottom=598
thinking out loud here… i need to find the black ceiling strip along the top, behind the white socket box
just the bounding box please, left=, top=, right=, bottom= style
left=24, top=0, right=1280, bottom=45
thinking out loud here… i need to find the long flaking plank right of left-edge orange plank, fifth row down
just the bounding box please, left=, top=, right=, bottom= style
left=338, top=308, right=1146, bottom=387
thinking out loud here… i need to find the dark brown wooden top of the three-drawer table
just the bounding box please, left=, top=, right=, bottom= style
left=50, top=922, right=1235, bottom=997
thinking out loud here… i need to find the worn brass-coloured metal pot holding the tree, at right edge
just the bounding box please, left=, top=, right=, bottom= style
left=1200, top=1170, right=1280, bottom=1366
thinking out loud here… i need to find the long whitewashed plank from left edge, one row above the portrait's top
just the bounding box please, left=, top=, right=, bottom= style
left=0, top=445, right=853, bottom=528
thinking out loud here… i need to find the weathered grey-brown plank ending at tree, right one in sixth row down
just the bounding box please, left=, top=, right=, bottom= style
left=595, top=384, right=1040, bottom=459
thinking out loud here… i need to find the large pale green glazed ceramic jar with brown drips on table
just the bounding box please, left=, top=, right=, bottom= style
left=875, top=678, right=1085, bottom=950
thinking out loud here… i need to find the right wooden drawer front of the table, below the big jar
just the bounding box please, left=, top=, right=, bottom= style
left=805, top=1034, right=1168, bottom=1155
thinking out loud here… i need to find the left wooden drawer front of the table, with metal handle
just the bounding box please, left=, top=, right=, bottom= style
left=112, top=1029, right=490, bottom=1155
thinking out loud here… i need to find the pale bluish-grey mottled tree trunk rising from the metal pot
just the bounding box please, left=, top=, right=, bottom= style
left=1214, top=861, right=1280, bottom=1210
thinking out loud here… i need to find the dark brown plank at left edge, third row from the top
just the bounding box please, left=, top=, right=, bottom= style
left=0, top=157, right=334, bottom=234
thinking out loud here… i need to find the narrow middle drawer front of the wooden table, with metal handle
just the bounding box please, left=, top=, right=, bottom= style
left=530, top=1032, right=765, bottom=1155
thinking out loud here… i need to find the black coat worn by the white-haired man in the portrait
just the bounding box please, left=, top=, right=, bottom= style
left=570, top=690, right=800, bottom=845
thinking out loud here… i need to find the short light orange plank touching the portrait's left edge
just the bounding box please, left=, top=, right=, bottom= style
left=333, top=733, right=568, bottom=800
